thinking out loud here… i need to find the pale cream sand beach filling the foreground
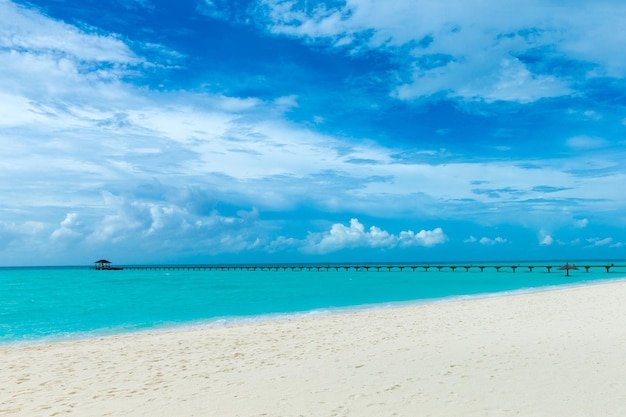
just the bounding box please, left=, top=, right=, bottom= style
left=0, top=282, right=626, bottom=417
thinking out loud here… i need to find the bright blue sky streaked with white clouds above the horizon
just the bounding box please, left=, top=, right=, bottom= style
left=0, top=0, right=626, bottom=266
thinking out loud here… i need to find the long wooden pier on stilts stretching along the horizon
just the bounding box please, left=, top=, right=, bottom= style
left=105, top=263, right=626, bottom=273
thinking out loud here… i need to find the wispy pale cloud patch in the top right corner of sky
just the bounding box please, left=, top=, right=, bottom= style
left=262, top=0, right=626, bottom=103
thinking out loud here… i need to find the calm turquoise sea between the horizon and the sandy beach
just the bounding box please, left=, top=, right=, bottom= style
left=0, top=260, right=626, bottom=345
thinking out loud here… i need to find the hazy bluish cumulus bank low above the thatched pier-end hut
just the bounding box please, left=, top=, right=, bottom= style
left=42, top=193, right=265, bottom=255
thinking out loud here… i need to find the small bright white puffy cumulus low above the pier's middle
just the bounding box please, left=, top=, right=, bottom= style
left=302, top=218, right=447, bottom=253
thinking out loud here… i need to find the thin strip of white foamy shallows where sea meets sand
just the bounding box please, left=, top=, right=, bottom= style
left=0, top=276, right=626, bottom=348
